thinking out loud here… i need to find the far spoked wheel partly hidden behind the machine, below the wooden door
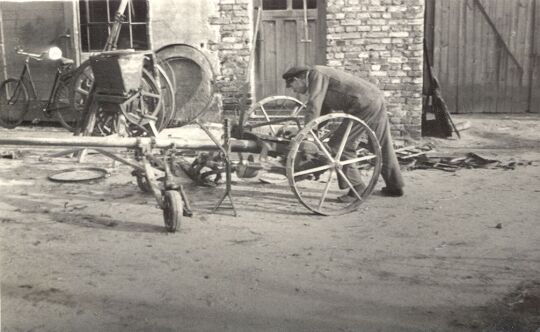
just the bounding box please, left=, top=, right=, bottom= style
left=240, top=96, right=306, bottom=136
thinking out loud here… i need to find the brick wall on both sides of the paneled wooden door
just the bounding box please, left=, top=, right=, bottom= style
left=210, top=0, right=424, bottom=138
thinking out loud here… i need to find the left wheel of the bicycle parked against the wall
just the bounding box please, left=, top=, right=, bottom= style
left=0, top=78, right=29, bottom=129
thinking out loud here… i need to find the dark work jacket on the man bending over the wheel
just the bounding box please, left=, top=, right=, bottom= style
left=305, top=66, right=384, bottom=123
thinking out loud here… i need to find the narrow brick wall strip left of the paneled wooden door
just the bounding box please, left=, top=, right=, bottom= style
left=209, top=0, right=253, bottom=116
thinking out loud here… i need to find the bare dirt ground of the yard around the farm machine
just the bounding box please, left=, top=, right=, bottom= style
left=0, top=114, right=540, bottom=332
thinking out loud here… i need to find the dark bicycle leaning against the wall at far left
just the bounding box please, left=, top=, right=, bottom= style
left=0, top=35, right=80, bottom=131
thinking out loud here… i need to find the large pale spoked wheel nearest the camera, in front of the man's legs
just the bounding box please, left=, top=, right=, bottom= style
left=287, top=113, right=382, bottom=215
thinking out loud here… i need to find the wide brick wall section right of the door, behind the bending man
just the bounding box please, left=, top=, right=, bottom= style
left=326, top=0, right=424, bottom=138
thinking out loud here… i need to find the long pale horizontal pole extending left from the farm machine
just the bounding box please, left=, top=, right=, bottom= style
left=0, top=136, right=261, bottom=153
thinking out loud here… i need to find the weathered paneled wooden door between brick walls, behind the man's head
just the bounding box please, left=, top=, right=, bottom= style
left=254, top=0, right=326, bottom=100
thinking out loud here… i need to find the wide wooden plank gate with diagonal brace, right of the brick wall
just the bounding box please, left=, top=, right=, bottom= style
left=426, top=0, right=538, bottom=113
